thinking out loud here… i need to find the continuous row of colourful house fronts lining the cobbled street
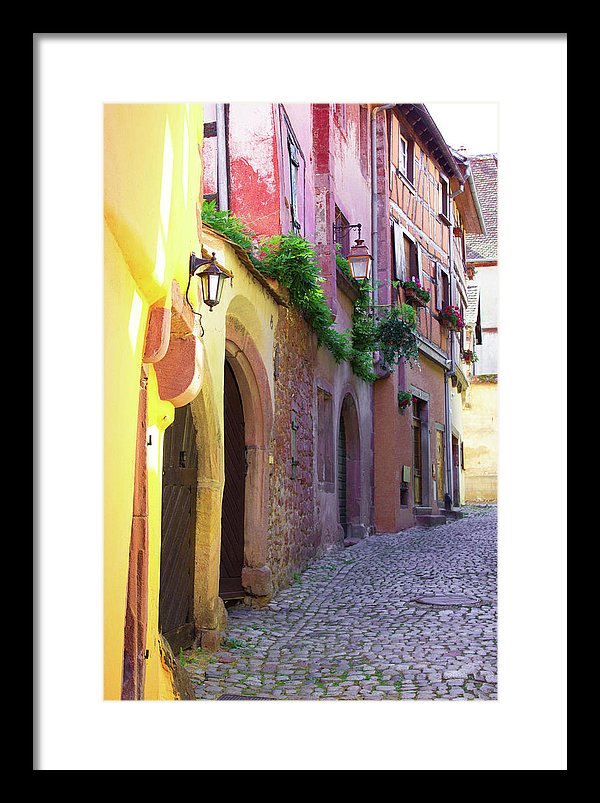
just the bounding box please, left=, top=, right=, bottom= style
left=105, top=103, right=488, bottom=699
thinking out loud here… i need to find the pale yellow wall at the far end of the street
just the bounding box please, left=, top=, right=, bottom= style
left=463, top=382, right=498, bottom=502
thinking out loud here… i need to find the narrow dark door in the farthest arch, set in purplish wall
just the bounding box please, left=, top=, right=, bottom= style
left=337, top=393, right=361, bottom=535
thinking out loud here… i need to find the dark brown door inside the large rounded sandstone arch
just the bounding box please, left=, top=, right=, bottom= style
left=219, top=361, right=246, bottom=599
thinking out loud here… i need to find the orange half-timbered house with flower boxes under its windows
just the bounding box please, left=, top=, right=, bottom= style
left=374, top=103, right=483, bottom=532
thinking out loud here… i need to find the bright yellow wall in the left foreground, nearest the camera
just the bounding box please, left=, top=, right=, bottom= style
left=104, top=104, right=203, bottom=700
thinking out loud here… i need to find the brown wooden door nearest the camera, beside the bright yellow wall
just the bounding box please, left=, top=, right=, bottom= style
left=158, top=404, right=198, bottom=653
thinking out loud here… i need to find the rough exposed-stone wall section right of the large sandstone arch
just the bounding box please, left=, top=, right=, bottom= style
left=267, top=308, right=318, bottom=590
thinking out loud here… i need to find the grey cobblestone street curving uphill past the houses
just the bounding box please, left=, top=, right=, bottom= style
left=180, top=505, right=497, bottom=700
